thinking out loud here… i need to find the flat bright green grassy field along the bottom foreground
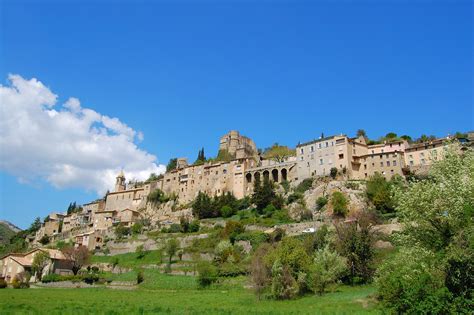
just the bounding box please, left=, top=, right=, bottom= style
left=0, top=271, right=378, bottom=314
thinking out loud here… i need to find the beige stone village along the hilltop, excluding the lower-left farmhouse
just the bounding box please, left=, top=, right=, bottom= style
left=31, top=131, right=472, bottom=249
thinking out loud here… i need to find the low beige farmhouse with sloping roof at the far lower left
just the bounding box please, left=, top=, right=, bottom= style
left=0, top=248, right=72, bottom=283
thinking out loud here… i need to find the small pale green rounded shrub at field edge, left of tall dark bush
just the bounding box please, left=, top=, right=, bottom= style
left=311, top=246, right=347, bottom=295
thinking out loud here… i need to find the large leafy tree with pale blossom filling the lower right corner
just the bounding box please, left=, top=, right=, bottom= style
left=377, top=144, right=474, bottom=314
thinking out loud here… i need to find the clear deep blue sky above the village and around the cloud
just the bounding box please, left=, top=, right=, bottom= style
left=0, top=0, right=474, bottom=227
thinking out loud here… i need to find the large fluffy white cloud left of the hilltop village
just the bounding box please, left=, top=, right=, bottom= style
left=0, top=75, right=165, bottom=194
